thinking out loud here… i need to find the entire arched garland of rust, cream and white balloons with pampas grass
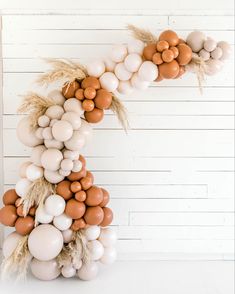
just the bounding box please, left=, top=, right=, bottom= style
left=0, top=25, right=231, bottom=280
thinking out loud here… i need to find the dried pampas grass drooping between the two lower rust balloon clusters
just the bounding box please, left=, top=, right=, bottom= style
left=20, top=178, right=55, bottom=218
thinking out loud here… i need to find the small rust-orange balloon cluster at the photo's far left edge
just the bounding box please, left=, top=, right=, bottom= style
left=0, top=189, right=36, bottom=236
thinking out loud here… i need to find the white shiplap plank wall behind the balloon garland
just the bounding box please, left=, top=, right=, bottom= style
left=0, top=0, right=234, bottom=259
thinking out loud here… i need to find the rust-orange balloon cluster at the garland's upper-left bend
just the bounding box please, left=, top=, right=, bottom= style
left=62, top=76, right=112, bottom=123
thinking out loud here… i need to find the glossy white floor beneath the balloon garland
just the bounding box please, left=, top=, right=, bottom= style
left=0, top=261, right=234, bottom=294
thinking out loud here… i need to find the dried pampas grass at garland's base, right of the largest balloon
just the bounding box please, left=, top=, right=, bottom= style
left=57, top=230, right=90, bottom=267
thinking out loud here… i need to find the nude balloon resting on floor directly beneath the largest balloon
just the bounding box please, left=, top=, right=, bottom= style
left=30, top=258, right=60, bottom=281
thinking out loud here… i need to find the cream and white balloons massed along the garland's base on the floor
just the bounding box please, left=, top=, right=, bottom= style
left=0, top=224, right=117, bottom=281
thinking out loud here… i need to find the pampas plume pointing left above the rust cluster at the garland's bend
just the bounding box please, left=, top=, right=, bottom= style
left=36, top=59, right=88, bottom=85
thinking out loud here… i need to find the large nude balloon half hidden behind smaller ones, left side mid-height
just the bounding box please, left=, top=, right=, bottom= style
left=16, top=116, right=43, bottom=147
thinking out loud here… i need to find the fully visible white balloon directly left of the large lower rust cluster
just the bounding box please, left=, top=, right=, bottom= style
left=45, top=194, right=65, bottom=216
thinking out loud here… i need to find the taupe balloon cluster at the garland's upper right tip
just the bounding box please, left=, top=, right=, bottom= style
left=186, top=31, right=231, bottom=75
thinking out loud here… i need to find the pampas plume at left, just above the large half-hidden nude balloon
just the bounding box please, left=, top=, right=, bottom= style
left=18, top=92, right=56, bottom=128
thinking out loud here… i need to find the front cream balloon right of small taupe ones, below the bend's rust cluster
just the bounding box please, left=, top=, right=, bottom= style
left=52, top=120, right=73, bottom=142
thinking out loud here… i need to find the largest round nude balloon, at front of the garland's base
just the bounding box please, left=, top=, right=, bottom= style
left=28, top=225, right=64, bottom=261
